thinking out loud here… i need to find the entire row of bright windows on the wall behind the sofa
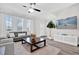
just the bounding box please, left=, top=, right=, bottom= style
left=4, top=16, right=32, bottom=31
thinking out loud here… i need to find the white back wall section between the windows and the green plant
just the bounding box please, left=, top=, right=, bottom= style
left=34, top=17, right=48, bottom=36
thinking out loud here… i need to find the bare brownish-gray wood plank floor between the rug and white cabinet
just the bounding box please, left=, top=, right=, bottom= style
left=47, top=40, right=79, bottom=55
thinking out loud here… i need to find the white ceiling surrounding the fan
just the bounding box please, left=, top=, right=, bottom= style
left=0, top=3, right=74, bottom=18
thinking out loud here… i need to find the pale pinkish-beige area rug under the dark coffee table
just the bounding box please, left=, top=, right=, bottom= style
left=15, top=43, right=60, bottom=55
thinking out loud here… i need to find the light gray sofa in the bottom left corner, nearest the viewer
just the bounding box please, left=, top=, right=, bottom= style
left=0, top=38, right=14, bottom=55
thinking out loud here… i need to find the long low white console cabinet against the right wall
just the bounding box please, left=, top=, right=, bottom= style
left=54, top=34, right=79, bottom=46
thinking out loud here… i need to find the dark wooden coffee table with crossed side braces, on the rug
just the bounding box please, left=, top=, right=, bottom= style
left=22, top=38, right=46, bottom=52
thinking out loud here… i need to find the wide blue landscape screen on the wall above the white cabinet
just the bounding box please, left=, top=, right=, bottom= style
left=56, top=16, right=77, bottom=29
